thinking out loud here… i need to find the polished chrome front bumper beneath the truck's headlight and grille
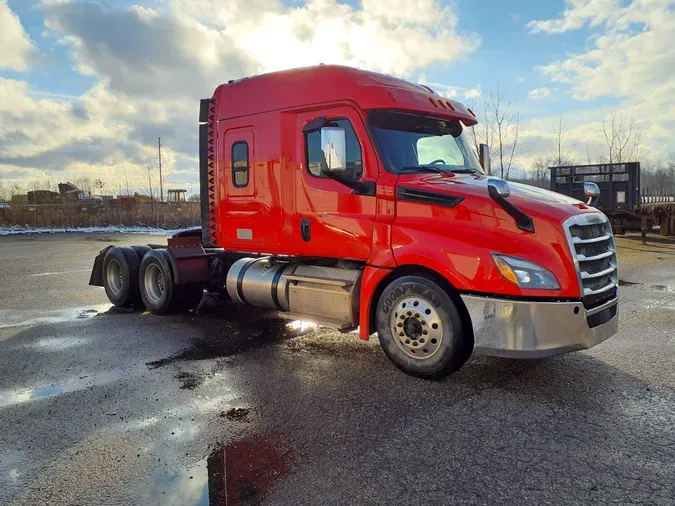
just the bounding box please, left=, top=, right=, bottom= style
left=462, top=295, right=619, bottom=358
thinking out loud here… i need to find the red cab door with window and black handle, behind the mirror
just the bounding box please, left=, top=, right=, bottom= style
left=294, top=106, right=378, bottom=261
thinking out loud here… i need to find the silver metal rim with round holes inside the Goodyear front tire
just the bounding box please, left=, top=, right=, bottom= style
left=389, top=297, right=443, bottom=360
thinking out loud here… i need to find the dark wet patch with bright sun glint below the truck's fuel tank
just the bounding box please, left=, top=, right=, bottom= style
left=146, top=294, right=316, bottom=369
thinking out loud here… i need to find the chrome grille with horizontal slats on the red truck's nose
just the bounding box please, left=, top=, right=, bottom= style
left=564, top=213, right=619, bottom=309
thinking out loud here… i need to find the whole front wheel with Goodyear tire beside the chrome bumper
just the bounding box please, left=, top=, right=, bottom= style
left=376, top=276, right=473, bottom=379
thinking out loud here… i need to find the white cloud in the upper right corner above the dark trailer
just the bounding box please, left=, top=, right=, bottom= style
left=530, top=0, right=675, bottom=160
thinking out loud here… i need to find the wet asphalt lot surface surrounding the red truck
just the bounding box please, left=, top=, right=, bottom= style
left=0, top=234, right=675, bottom=506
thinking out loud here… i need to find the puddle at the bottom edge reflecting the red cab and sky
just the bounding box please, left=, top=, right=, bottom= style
left=152, top=437, right=290, bottom=506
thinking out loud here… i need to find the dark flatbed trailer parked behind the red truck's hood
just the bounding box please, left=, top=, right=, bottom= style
left=550, top=162, right=675, bottom=240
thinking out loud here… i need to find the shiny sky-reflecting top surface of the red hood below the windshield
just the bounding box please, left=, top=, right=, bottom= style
left=398, top=174, right=595, bottom=221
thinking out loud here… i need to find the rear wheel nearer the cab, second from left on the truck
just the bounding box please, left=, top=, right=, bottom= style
left=138, top=250, right=183, bottom=315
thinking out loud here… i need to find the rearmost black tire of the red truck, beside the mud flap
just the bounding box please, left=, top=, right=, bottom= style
left=103, top=246, right=141, bottom=307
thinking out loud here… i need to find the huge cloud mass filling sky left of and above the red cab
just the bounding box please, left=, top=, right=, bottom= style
left=0, top=0, right=480, bottom=192
